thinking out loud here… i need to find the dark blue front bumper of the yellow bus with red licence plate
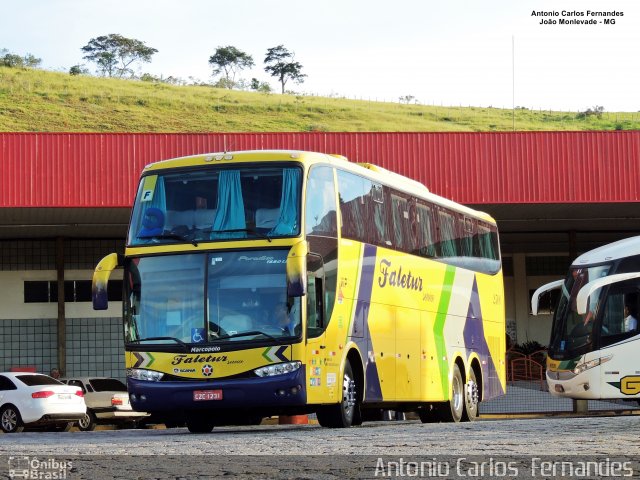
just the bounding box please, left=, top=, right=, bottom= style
left=127, top=368, right=307, bottom=412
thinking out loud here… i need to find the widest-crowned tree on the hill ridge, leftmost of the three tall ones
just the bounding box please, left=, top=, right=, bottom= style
left=82, top=33, right=158, bottom=77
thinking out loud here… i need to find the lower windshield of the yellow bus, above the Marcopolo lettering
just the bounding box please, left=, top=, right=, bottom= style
left=124, top=250, right=301, bottom=348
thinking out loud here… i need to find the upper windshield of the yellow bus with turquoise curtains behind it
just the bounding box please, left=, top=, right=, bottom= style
left=128, top=164, right=302, bottom=246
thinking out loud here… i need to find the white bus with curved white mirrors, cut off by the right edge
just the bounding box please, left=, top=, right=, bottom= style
left=531, top=236, right=640, bottom=402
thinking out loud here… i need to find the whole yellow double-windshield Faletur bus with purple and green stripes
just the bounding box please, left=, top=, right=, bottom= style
left=93, top=151, right=505, bottom=432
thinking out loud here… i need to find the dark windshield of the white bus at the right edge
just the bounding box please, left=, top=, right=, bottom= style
left=549, top=264, right=611, bottom=359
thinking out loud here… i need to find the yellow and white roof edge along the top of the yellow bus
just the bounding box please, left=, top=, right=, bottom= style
left=144, top=150, right=496, bottom=224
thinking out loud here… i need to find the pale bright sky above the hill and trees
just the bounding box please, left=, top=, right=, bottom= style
left=0, top=0, right=640, bottom=112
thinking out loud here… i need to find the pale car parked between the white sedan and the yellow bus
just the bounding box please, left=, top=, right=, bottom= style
left=60, top=377, right=149, bottom=431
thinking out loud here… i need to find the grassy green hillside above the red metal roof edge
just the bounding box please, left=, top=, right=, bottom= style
left=0, top=67, right=640, bottom=132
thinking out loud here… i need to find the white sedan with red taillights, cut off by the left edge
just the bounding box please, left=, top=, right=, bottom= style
left=0, top=372, right=87, bottom=433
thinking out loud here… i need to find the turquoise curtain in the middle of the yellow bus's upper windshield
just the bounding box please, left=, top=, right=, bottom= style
left=211, top=170, right=246, bottom=239
